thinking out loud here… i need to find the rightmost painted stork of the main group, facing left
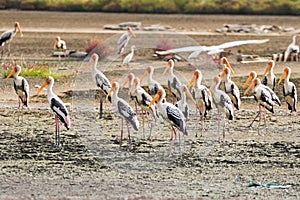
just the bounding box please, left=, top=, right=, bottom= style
left=278, top=67, right=297, bottom=113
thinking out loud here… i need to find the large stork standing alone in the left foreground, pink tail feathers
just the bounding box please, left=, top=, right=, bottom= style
left=37, top=76, right=71, bottom=146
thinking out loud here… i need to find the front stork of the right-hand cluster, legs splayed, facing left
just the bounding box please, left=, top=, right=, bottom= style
left=244, top=78, right=276, bottom=134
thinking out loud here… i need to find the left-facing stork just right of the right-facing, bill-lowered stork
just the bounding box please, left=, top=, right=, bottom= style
left=189, top=69, right=212, bottom=137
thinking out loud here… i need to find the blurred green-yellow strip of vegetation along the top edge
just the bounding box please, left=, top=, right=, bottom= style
left=0, top=0, right=300, bottom=15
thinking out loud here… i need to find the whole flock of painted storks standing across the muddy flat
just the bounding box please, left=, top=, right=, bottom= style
left=0, top=22, right=297, bottom=146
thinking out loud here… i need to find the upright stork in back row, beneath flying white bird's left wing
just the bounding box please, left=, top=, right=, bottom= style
left=163, top=59, right=182, bottom=101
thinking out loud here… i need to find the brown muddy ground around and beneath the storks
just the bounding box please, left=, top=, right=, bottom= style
left=0, top=11, right=300, bottom=199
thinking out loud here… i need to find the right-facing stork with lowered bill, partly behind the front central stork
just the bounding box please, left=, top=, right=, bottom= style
left=175, top=84, right=196, bottom=120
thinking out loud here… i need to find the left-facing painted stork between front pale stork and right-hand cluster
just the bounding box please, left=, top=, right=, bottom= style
left=220, top=67, right=241, bottom=110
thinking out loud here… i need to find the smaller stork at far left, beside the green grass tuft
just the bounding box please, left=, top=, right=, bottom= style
left=6, top=65, right=29, bottom=121
